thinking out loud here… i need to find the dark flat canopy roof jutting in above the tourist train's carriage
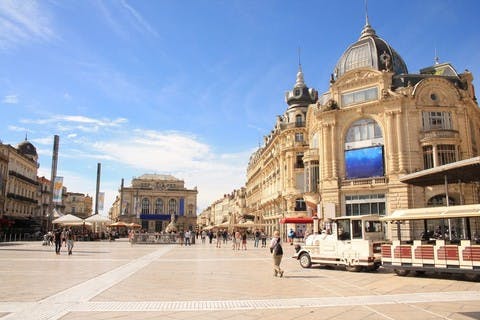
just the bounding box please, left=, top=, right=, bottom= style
left=400, top=157, right=480, bottom=187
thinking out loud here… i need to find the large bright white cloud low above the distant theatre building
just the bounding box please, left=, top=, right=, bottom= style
left=87, top=130, right=251, bottom=208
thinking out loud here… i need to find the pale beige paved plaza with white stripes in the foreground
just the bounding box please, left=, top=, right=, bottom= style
left=0, top=240, right=480, bottom=320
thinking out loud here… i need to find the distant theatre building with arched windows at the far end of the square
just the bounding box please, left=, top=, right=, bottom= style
left=110, top=174, right=198, bottom=232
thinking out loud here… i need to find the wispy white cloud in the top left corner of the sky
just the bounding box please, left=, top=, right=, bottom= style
left=0, top=0, right=55, bottom=49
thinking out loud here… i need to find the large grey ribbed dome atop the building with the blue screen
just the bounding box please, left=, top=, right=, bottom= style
left=333, top=17, right=408, bottom=80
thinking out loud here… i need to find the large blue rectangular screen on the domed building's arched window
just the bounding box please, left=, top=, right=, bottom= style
left=345, top=146, right=384, bottom=179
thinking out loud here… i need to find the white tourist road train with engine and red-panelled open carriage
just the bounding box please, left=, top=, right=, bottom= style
left=294, top=204, right=480, bottom=281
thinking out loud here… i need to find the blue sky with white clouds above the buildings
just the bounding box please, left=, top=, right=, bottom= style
left=0, top=0, right=480, bottom=212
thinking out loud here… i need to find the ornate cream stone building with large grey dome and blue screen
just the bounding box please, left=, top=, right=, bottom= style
left=303, top=19, right=480, bottom=228
